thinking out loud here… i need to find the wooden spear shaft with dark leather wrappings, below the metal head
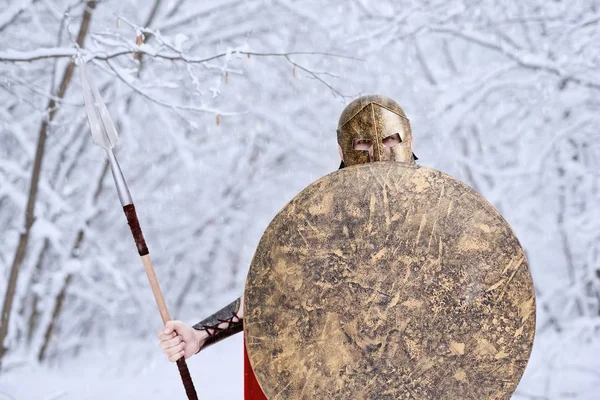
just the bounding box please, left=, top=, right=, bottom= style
left=123, top=203, right=198, bottom=400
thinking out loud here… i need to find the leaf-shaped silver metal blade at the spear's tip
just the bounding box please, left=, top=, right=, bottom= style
left=79, top=61, right=119, bottom=150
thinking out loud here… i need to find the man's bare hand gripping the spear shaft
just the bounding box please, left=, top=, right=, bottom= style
left=158, top=321, right=208, bottom=362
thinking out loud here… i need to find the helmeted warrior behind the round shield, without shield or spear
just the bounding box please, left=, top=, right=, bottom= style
left=158, top=95, right=417, bottom=400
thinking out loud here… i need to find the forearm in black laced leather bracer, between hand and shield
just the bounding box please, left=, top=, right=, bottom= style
left=193, top=297, right=243, bottom=351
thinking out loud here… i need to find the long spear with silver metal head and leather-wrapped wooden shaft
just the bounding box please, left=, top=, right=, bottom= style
left=79, top=57, right=198, bottom=400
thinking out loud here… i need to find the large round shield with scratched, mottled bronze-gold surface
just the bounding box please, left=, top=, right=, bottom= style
left=244, top=162, right=535, bottom=400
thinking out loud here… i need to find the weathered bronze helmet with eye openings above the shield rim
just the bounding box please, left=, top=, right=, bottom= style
left=337, top=95, right=417, bottom=166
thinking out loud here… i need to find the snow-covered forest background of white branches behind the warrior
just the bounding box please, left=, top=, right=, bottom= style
left=0, top=0, right=600, bottom=400
